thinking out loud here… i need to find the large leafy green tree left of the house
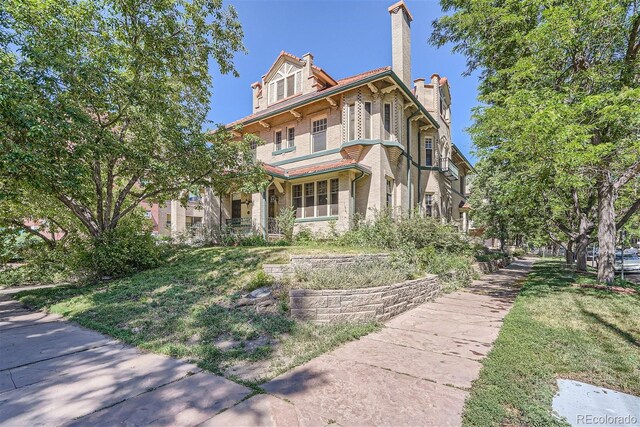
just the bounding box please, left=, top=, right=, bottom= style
left=0, top=0, right=263, bottom=268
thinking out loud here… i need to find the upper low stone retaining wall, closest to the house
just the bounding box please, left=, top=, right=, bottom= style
left=262, top=254, right=389, bottom=279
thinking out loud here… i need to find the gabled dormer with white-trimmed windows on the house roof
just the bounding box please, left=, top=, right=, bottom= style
left=251, top=51, right=337, bottom=112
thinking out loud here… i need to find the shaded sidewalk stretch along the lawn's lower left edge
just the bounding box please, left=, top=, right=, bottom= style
left=0, top=290, right=251, bottom=427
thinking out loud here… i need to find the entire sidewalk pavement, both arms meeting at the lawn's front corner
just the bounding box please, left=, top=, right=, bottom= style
left=0, top=260, right=533, bottom=426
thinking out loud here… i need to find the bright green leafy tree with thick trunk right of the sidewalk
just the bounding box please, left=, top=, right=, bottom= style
left=431, top=0, right=640, bottom=283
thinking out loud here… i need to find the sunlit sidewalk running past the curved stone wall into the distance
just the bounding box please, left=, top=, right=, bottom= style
left=204, top=259, right=533, bottom=426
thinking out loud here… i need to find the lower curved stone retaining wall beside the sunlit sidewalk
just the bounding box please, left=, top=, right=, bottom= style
left=289, top=275, right=441, bottom=323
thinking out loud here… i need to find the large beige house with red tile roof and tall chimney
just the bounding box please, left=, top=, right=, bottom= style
left=158, top=1, right=473, bottom=239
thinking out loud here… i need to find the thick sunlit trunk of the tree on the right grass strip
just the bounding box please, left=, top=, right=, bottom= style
left=598, top=180, right=616, bottom=285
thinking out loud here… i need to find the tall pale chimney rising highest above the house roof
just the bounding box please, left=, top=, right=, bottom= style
left=389, top=0, right=413, bottom=88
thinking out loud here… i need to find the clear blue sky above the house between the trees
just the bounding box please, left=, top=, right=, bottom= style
left=208, top=0, right=478, bottom=163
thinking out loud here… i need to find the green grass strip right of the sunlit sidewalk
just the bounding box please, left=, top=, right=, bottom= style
left=463, top=261, right=640, bottom=427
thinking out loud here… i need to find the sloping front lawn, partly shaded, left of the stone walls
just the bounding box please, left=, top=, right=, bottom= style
left=16, top=246, right=377, bottom=383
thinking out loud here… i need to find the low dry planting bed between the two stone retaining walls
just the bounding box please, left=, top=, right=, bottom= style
left=293, top=261, right=411, bottom=289
